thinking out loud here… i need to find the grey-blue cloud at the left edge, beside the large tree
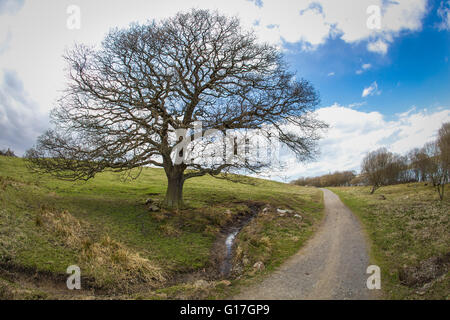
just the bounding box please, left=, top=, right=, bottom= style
left=0, top=70, right=48, bottom=155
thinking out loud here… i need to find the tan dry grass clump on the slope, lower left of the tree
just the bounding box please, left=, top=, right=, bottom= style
left=36, top=207, right=165, bottom=291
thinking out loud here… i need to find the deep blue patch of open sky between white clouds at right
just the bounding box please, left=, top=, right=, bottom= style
left=287, top=1, right=450, bottom=116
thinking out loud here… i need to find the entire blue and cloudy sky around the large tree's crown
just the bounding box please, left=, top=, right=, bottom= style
left=0, top=0, right=450, bottom=180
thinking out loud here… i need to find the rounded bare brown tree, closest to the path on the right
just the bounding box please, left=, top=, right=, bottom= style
left=361, top=148, right=405, bottom=194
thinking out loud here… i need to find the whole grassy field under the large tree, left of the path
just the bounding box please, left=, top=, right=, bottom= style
left=0, top=157, right=323, bottom=299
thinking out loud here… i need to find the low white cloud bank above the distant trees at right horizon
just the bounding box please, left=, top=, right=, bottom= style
left=275, top=104, right=450, bottom=179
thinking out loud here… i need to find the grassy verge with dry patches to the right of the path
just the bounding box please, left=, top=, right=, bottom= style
left=330, top=183, right=450, bottom=299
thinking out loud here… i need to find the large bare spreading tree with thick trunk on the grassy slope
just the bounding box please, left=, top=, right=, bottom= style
left=27, top=10, right=326, bottom=207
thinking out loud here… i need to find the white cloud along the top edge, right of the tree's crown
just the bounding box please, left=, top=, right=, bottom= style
left=244, top=0, right=427, bottom=54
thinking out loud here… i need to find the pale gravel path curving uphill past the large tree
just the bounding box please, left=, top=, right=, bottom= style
left=235, top=189, right=375, bottom=300
